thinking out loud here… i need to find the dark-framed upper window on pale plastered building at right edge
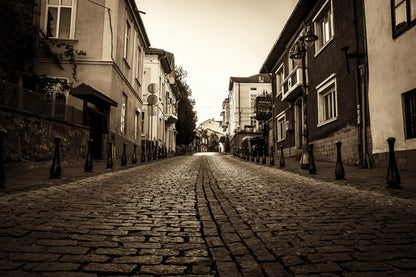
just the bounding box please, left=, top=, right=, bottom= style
left=390, top=0, right=416, bottom=38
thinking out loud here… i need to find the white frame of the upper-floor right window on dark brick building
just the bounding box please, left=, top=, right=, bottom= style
left=312, top=0, right=335, bottom=57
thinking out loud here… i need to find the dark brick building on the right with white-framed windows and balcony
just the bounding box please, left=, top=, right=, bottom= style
left=260, top=0, right=371, bottom=166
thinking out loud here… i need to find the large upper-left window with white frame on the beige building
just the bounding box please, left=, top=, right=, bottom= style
left=46, top=0, right=75, bottom=39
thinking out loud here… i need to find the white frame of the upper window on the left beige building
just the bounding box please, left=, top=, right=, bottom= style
left=44, top=0, right=77, bottom=40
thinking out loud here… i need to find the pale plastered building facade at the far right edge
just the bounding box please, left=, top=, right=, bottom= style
left=364, top=0, right=416, bottom=171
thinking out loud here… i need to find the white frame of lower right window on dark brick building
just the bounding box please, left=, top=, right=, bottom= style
left=316, top=74, right=338, bottom=127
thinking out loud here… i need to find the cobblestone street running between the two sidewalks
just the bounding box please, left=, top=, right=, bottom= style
left=0, top=153, right=416, bottom=277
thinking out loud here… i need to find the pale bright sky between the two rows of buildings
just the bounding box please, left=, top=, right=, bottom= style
left=136, top=0, right=297, bottom=124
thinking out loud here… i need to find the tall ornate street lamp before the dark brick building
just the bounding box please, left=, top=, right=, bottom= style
left=289, top=25, right=318, bottom=170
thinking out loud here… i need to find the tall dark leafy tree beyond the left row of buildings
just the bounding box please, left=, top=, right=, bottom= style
left=175, top=66, right=197, bottom=145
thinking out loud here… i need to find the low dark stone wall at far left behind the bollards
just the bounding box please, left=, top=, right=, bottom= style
left=0, top=106, right=90, bottom=167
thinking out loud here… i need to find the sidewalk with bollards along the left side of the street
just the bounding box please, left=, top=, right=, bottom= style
left=0, top=157, right=162, bottom=195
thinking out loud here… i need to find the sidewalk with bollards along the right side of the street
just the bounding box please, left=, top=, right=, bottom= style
left=235, top=153, right=416, bottom=199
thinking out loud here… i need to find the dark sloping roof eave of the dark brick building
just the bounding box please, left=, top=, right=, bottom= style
left=260, top=0, right=318, bottom=73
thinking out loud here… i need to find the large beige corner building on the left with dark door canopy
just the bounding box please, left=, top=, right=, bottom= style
left=35, top=0, right=150, bottom=159
